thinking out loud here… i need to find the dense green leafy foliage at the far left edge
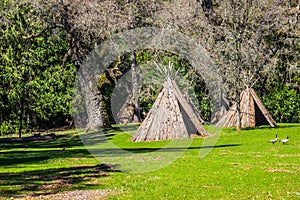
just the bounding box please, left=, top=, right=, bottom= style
left=0, top=2, right=76, bottom=134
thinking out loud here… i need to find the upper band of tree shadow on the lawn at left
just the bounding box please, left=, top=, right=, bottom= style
left=0, top=135, right=92, bottom=168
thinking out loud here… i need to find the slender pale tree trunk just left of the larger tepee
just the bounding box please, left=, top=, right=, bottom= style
left=130, top=50, right=142, bottom=123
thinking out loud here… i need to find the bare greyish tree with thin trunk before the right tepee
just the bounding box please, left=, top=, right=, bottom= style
left=210, top=1, right=299, bottom=130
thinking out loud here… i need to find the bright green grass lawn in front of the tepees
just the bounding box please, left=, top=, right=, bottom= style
left=0, top=124, right=300, bottom=199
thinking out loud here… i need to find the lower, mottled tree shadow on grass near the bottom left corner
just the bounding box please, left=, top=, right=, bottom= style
left=0, top=164, right=119, bottom=199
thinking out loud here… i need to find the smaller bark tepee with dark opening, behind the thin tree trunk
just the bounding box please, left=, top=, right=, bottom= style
left=216, top=88, right=276, bottom=127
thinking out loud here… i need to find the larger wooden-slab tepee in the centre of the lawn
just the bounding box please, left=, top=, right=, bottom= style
left=132, top=61, right=208, bottom=142
